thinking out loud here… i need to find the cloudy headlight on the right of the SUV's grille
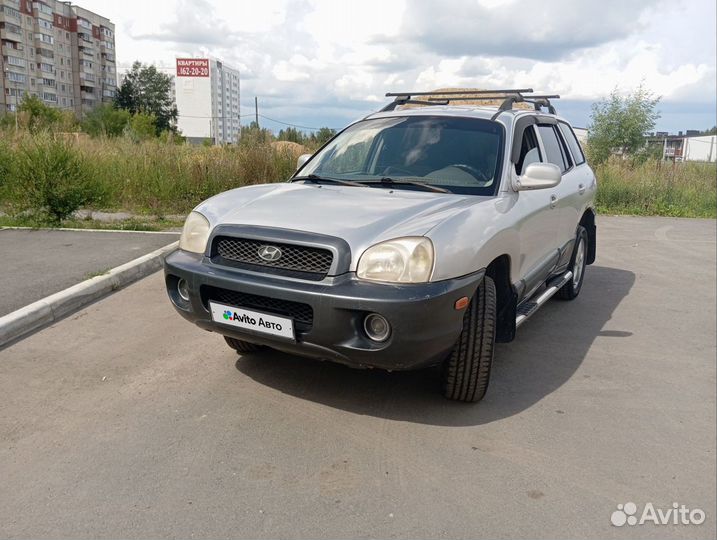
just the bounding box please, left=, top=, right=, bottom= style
left=356, top=236, right=433, bottom=283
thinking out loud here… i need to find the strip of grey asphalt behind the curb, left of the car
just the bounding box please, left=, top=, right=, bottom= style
left=0, top=229, right=178, bottom=317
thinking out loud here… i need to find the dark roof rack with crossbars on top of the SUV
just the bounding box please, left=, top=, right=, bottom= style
left=380, top=88, right=560, bottom=120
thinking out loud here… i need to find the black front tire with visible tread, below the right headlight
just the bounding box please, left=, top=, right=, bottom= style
left=443, top=277, right=496, bottom=403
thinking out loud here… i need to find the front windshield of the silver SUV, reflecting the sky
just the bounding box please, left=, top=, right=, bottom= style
left=298, top=116, right=503, bottom=195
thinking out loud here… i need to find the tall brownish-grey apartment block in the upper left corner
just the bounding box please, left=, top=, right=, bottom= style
left=0, top=0, right=117, bottom=115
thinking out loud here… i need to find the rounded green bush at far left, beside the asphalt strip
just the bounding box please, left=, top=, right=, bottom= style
left=7, top=134, right=103, bottom=225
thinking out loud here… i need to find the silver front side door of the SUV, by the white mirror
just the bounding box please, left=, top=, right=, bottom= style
left=514, top=126, right=560, bottom=295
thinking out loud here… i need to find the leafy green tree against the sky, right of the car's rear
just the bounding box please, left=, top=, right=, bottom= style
left=587, top=84, right=660, bottom=164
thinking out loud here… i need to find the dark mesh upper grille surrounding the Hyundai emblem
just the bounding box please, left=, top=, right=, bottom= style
left=212, top=236, right=334, bottom=280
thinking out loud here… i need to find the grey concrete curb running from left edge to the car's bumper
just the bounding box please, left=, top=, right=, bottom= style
left=0, top=242, right=179, bottom=348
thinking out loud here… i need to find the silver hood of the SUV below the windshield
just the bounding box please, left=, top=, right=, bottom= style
left=196, top=183, right=486, bottom=260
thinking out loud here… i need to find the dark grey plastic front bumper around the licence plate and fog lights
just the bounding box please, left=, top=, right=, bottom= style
left=164, top=250, right=484, bottom=370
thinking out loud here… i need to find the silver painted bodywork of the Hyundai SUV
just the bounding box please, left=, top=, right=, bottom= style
left=190, top=106, right=595, bottom=282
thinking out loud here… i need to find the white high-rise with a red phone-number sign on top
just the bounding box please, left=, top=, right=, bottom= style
left=175, top=58, right=240, bottom=144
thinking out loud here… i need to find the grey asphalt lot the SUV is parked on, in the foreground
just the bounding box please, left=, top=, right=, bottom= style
left=0, top=217, right=716, bottom=539
